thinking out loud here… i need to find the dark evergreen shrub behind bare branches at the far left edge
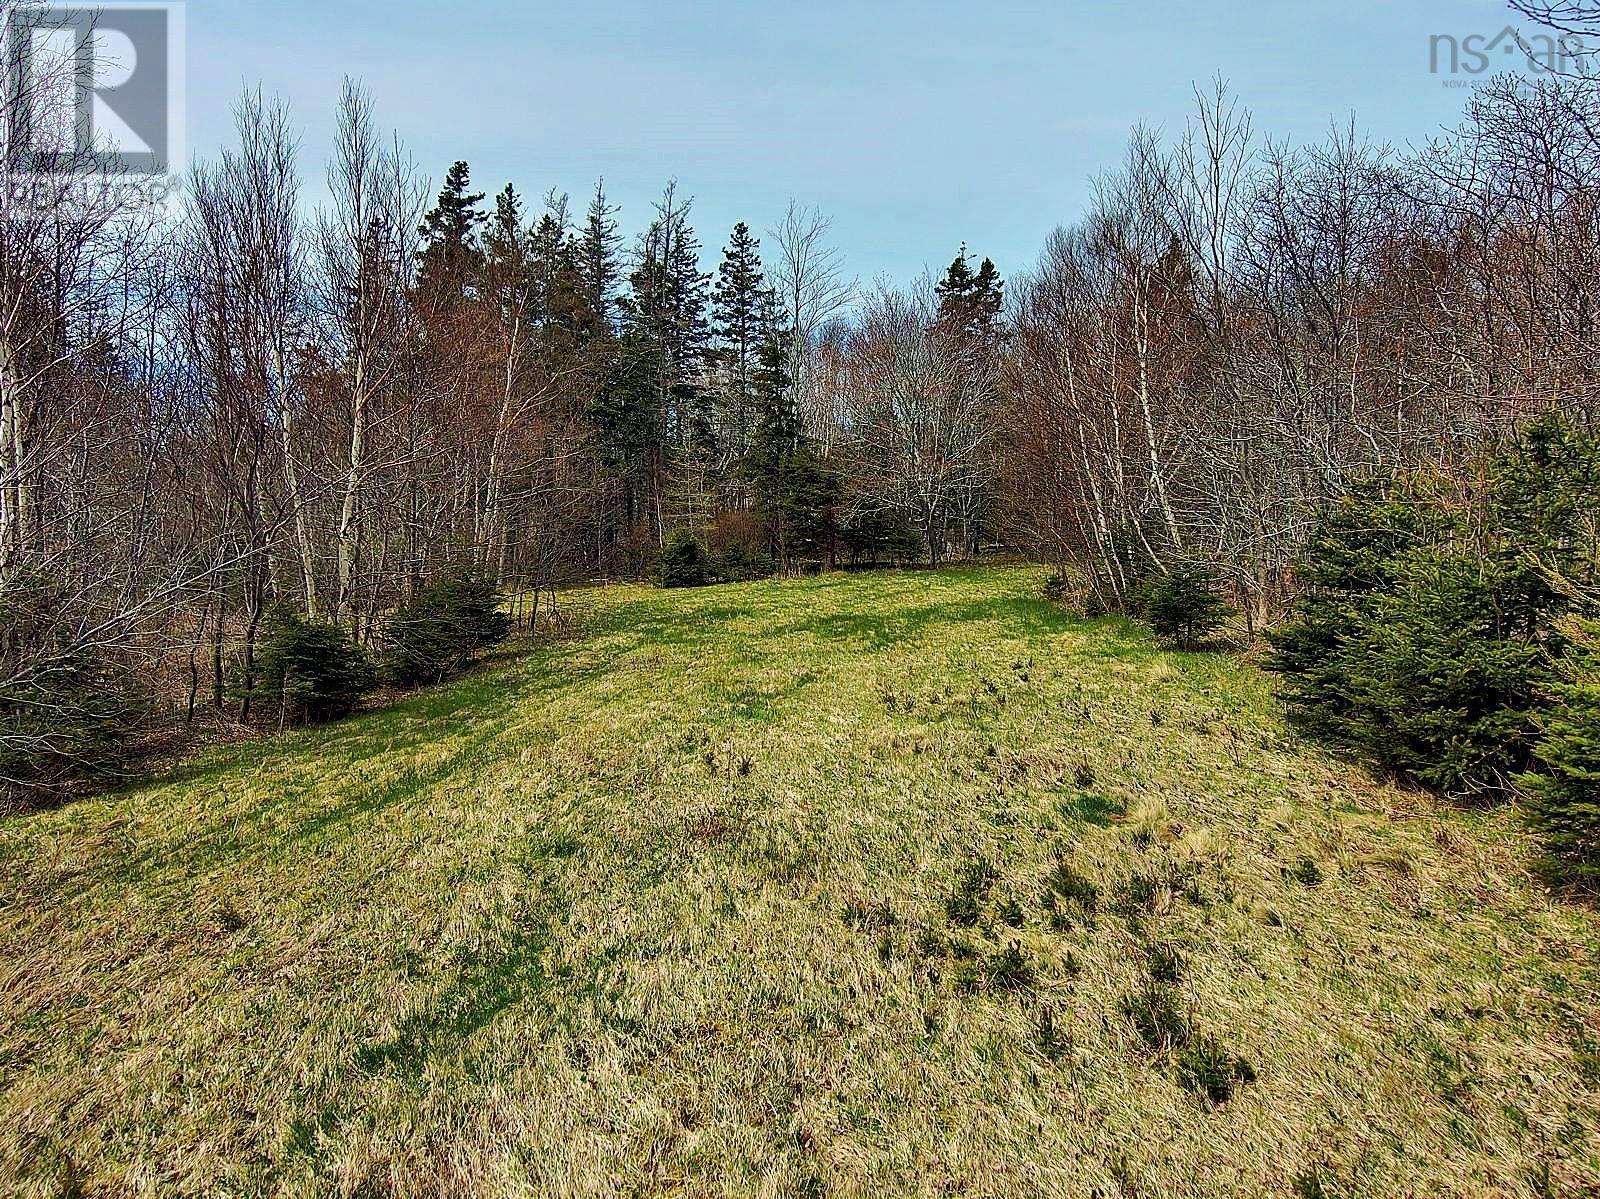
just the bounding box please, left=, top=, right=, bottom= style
left=0, top=578, right=147, bottom=810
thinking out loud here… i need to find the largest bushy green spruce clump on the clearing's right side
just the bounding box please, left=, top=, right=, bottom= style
left=1269, top=419, right=1600, bottom=794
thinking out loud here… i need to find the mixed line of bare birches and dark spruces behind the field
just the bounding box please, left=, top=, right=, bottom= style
left=0, top=23, right=1600, bottom=819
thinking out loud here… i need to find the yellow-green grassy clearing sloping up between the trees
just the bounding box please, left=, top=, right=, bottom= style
left=0, top=570, right=1600, bottom=1199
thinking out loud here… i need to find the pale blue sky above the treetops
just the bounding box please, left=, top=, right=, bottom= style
left=187, top=0, right=1529, bottom=280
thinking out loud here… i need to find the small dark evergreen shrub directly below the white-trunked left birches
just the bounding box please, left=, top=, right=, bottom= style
left=238, top=605, right=374, bottom=724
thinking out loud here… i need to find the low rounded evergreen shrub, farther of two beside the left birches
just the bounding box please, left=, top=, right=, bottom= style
left=382, top=575, right=510, bottom=687
